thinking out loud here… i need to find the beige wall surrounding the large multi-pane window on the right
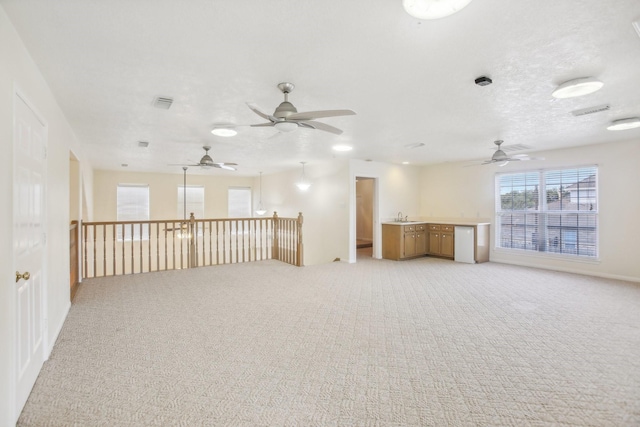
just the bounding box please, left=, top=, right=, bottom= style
left=420, top=139, right=640, bottom=281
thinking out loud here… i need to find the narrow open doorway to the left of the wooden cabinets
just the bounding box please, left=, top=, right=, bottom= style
left=355, top=177, right=375, bottom=258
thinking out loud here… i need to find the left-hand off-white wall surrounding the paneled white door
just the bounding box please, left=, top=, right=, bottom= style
left=0, top=6, right=92, bottom=426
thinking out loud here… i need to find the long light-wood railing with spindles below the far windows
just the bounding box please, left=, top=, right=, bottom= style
left=81, top=213, right=303, bottom=278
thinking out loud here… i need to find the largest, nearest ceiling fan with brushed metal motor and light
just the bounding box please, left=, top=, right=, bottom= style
left=247, top=83, right=356, bottom=135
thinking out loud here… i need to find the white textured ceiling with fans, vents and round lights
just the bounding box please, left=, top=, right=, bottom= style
left=0, top=0, right=640, bottom=175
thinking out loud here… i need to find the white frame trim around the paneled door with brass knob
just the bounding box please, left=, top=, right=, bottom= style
left=9, top=83, right=52, bottom=422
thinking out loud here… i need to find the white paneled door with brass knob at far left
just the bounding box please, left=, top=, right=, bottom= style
left=13, top=95, right=46, bottom=417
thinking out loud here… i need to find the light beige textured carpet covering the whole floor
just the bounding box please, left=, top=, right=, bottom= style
left=18, top=257, right=640, bottom=426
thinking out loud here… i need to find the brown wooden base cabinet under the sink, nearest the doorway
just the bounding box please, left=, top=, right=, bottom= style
left=382, top=224, right=427, bottom=260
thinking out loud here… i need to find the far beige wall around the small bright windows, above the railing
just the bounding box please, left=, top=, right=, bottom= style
left=93, top=170, right=254, bottom=221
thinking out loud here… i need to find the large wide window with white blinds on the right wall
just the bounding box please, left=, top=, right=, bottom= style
left=496, top=166, right=598, bottom=258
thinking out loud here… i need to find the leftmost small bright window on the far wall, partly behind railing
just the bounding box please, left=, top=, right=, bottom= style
left=116, top=184, right=149, bottom=241
